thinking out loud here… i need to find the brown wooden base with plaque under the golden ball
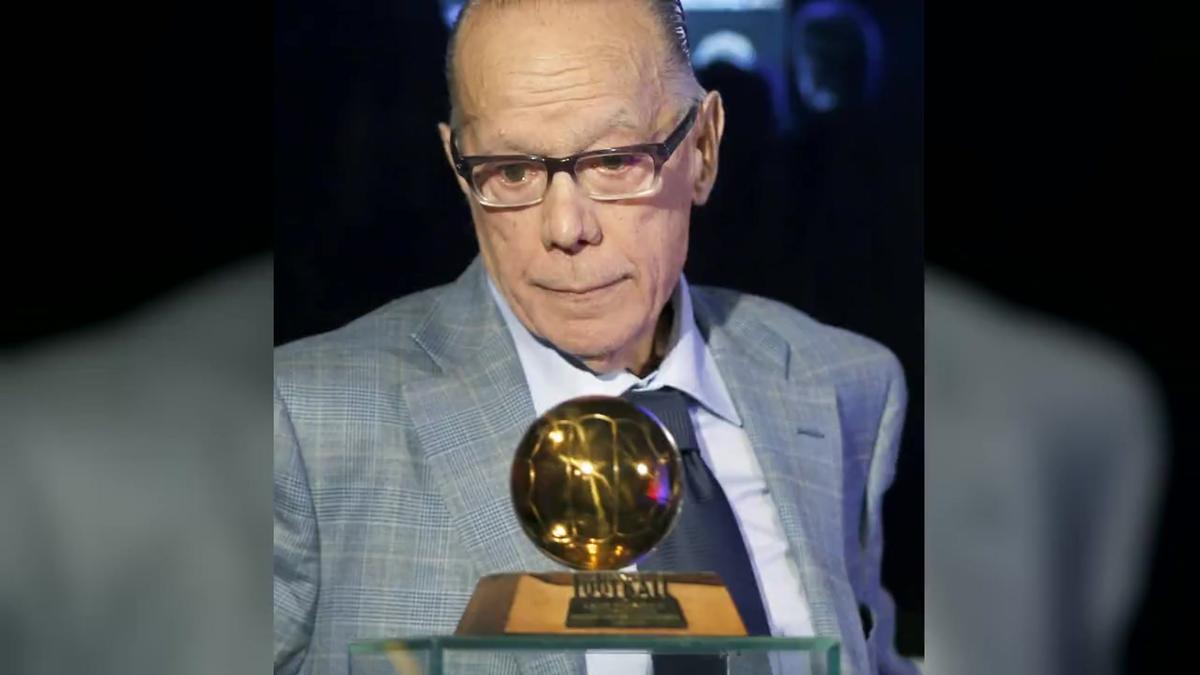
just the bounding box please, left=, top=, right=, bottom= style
left=455, top=572, right=746, bottom=637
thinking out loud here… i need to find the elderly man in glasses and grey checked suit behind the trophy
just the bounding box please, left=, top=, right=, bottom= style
left=275, top=0, right=919, bottom=675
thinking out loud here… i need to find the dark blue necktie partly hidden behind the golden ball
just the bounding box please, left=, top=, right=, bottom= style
left=624, top=388, right=770, bottom=675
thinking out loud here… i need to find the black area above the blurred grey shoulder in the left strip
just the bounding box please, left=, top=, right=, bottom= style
left=0, top=1, right=272, bottom=350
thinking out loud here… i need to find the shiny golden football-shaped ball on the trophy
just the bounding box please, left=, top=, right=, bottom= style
left=512, top=396, right=683, bottom=569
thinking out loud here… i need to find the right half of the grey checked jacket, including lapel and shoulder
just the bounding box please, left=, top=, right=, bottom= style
left=692, top=286, right=914, bottom=675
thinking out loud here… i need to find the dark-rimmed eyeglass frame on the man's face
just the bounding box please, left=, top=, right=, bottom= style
left=450, top=103, right=700, bottom=208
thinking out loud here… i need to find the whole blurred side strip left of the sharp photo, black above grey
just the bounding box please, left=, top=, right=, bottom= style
left=0, top=1, right=272, bottom=675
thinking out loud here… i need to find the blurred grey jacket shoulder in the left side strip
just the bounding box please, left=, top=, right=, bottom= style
left=0, top=257, right=271, bottom=675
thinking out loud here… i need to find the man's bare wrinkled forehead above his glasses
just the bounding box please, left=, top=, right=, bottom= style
left=455, top=2, right=672, bottom=154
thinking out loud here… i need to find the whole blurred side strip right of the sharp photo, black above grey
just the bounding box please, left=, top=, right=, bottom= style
left=916, top=4, right=1200, bottom=674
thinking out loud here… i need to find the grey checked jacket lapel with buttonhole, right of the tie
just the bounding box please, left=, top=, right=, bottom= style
left=692, top=285, right=866, bottom=673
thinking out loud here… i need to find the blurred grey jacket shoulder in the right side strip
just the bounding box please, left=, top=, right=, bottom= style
left=924, top=268, right=1166, bottom=675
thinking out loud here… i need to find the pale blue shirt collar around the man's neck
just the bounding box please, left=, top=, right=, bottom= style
left=487, top=274, right=742, bottom=426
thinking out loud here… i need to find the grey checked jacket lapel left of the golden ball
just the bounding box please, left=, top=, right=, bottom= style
left=403, top=258, right=583, bottom=674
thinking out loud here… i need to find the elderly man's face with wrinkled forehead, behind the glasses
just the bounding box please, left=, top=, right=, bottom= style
left=442, top=1, right=719, bottom=371
